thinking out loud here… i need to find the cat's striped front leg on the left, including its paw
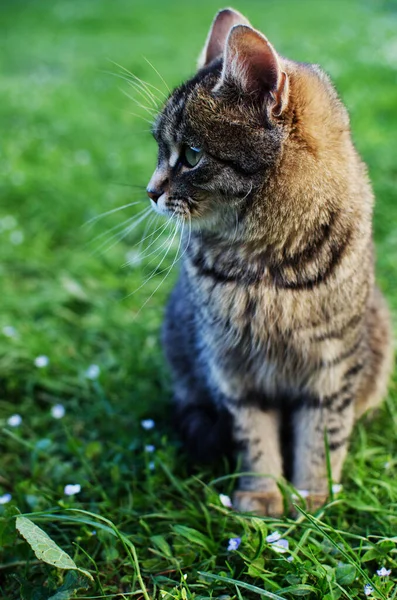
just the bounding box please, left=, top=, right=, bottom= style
left=229, top=403, right=283, bottom=516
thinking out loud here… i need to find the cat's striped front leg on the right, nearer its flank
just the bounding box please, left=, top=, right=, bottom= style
left=292, top=384, right=355, bottom=509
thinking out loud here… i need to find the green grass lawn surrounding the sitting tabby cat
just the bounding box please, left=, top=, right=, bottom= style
left=0, top=0, right=397, bottom=600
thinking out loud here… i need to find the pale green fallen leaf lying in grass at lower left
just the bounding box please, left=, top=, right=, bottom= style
left=15, top=517, right=94, bottom=581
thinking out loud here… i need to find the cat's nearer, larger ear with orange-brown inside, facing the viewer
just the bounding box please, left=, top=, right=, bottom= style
left=215, top=25, right=288, bottom=116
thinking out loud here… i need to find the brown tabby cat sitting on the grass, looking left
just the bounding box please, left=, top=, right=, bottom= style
left=147, top=9, right=392, bottom=515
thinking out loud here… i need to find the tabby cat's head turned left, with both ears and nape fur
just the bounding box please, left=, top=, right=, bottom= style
left=147, top=9, right=348, bottom=237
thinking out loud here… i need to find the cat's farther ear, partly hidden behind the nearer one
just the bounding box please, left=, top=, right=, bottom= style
left=197, top=8, right=249, bottom=69
